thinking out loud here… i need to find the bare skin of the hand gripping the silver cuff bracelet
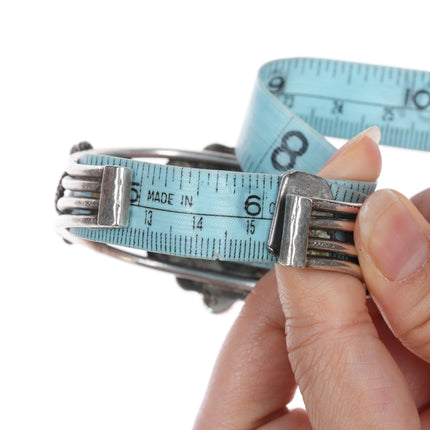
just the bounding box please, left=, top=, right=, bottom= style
left=194, top=132, right=430, bottom=430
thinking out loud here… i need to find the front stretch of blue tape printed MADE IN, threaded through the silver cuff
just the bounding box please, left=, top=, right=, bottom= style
left=73, top=149, right=374, bottom=263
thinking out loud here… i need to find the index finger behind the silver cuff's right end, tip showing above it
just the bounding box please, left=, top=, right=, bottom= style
left=276, top=127, right=420, bottom=430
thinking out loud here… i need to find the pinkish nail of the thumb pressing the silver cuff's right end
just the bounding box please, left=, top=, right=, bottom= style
left=358, top=190, right=429, bottom=281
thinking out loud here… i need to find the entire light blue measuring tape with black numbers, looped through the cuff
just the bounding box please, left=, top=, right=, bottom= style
left=70, top=58, right=430, bottom=265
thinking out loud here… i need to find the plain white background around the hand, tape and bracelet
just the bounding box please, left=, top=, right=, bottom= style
left=0, top=0, right=430, bottom=430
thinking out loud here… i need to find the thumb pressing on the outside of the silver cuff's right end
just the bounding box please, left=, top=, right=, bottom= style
left=355, top=190, right=430, bottom=362
